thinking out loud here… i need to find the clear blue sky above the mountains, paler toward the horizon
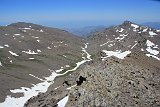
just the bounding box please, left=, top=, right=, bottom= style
left=0, top=0, right=160, bottom=27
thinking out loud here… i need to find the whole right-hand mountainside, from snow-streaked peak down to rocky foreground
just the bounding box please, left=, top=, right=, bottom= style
left=2, top=21, right=160, bottom=107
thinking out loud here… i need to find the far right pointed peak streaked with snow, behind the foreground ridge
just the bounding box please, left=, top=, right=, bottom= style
left=88, top=21, right=160, bottom=60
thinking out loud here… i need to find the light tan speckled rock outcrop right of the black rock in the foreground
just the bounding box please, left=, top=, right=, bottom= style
left=66, top=58, right=160, bottom=107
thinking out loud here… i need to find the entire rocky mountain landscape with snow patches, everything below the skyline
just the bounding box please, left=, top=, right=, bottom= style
left=0, top=21, right=160, bottom=107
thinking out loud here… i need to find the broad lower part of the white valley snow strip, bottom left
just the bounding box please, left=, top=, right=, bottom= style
left=0, top=72, right=57, bottom=107
